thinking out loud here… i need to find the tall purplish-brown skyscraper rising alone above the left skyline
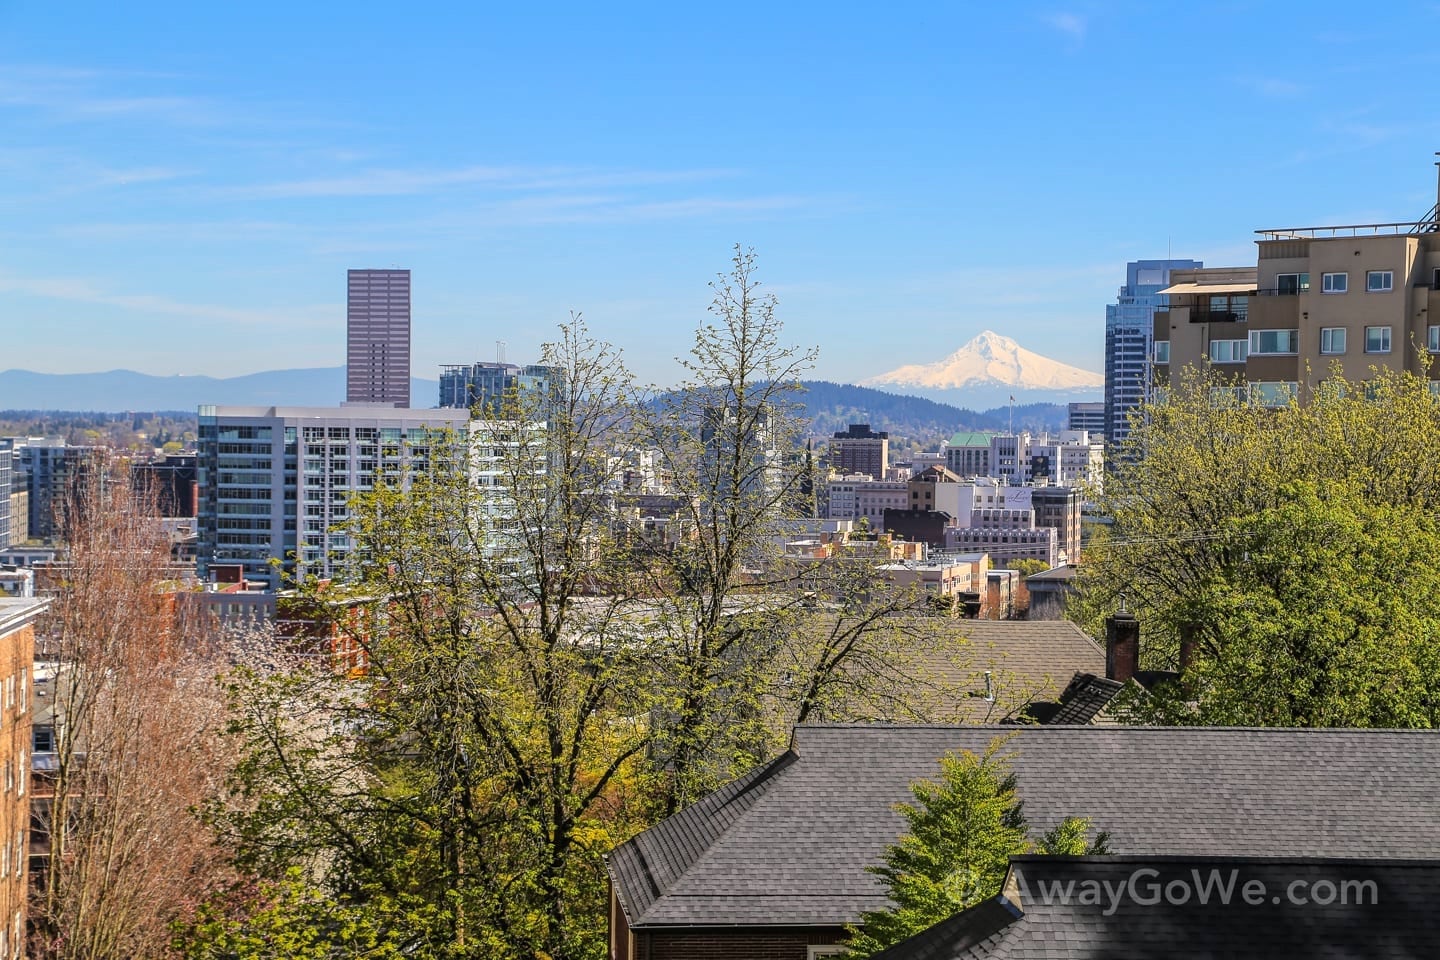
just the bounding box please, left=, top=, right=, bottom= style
left=346, top=271, right=410, bottom=407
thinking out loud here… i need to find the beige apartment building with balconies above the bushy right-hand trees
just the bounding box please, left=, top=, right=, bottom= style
left=1153, top=195, right=1440, bottom=406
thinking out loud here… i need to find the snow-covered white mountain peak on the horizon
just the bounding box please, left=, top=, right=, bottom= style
left=860, top=330, right=1104, bottom=402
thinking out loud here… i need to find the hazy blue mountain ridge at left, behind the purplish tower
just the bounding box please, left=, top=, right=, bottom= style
left=0, top=367, right=439, bottom=412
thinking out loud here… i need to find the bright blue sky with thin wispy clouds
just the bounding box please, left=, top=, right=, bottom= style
left=0, top=0, right=1440, bottom=383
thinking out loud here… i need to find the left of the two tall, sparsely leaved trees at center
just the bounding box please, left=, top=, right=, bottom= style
left=203, top=322, right=651, bottom=960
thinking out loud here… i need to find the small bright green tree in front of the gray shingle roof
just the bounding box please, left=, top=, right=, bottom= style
left=848, top=738, right=1110, bottom=957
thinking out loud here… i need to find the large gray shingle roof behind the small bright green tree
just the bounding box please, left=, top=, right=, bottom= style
left=609, top=724, right=1440, bottom=928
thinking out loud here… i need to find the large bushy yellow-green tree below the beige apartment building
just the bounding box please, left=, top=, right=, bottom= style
left=1073, top=373, right=1440, bottom=727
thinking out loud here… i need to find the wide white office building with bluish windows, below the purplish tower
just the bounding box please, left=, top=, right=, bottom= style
left=197, top=406, right=469, bottom=590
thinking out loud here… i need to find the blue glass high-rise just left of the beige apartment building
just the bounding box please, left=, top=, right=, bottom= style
left=1104, top=261, right=1204, bottom=446
